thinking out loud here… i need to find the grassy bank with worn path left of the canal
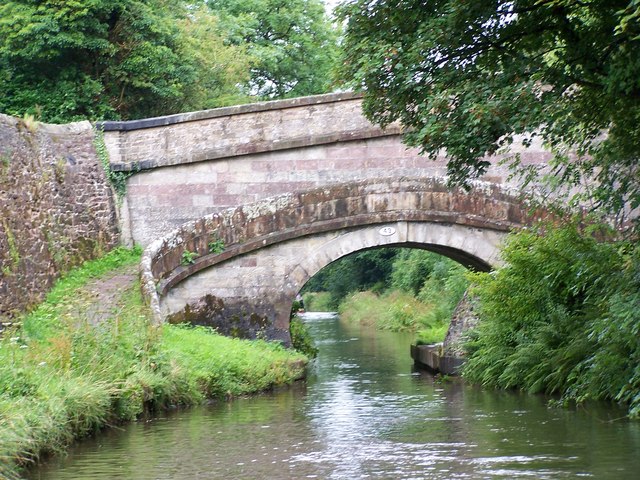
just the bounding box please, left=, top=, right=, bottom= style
left=0, top=249, right=306, bottom=479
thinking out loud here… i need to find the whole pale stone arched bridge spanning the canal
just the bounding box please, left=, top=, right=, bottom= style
left=102, top=94, right=549, bottom=343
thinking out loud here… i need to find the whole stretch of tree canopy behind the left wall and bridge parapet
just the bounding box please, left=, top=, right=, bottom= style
left=0, top=0, right=337, bottom=122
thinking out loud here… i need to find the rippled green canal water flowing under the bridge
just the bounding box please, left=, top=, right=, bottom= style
left=29, top=314, right=640, bottom=480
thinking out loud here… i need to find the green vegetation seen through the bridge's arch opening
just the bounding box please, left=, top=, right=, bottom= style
left=305, top=248, right=468, bottom=343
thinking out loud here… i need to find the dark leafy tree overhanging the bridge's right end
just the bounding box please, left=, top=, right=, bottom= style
left=338, top=0, right=640, bottom=229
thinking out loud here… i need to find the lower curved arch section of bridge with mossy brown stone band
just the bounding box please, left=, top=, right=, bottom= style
left=141, top=178, right=531, bottom=343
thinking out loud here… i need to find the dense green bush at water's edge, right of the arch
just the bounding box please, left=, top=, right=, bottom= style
left=464, top=224, right=640, bottom=417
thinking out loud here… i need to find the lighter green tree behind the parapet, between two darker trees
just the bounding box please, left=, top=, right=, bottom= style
left=207, top=0, right=337, bottom=98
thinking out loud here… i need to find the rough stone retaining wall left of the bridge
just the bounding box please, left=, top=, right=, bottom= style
left=0, top=114, right=118, bottom=316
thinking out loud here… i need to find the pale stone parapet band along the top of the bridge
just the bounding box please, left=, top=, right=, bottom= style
left=97, top=93, right=399, bottom=171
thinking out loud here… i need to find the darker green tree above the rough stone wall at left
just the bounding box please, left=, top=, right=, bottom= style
left=0, top=0, right=248, bottom=122
